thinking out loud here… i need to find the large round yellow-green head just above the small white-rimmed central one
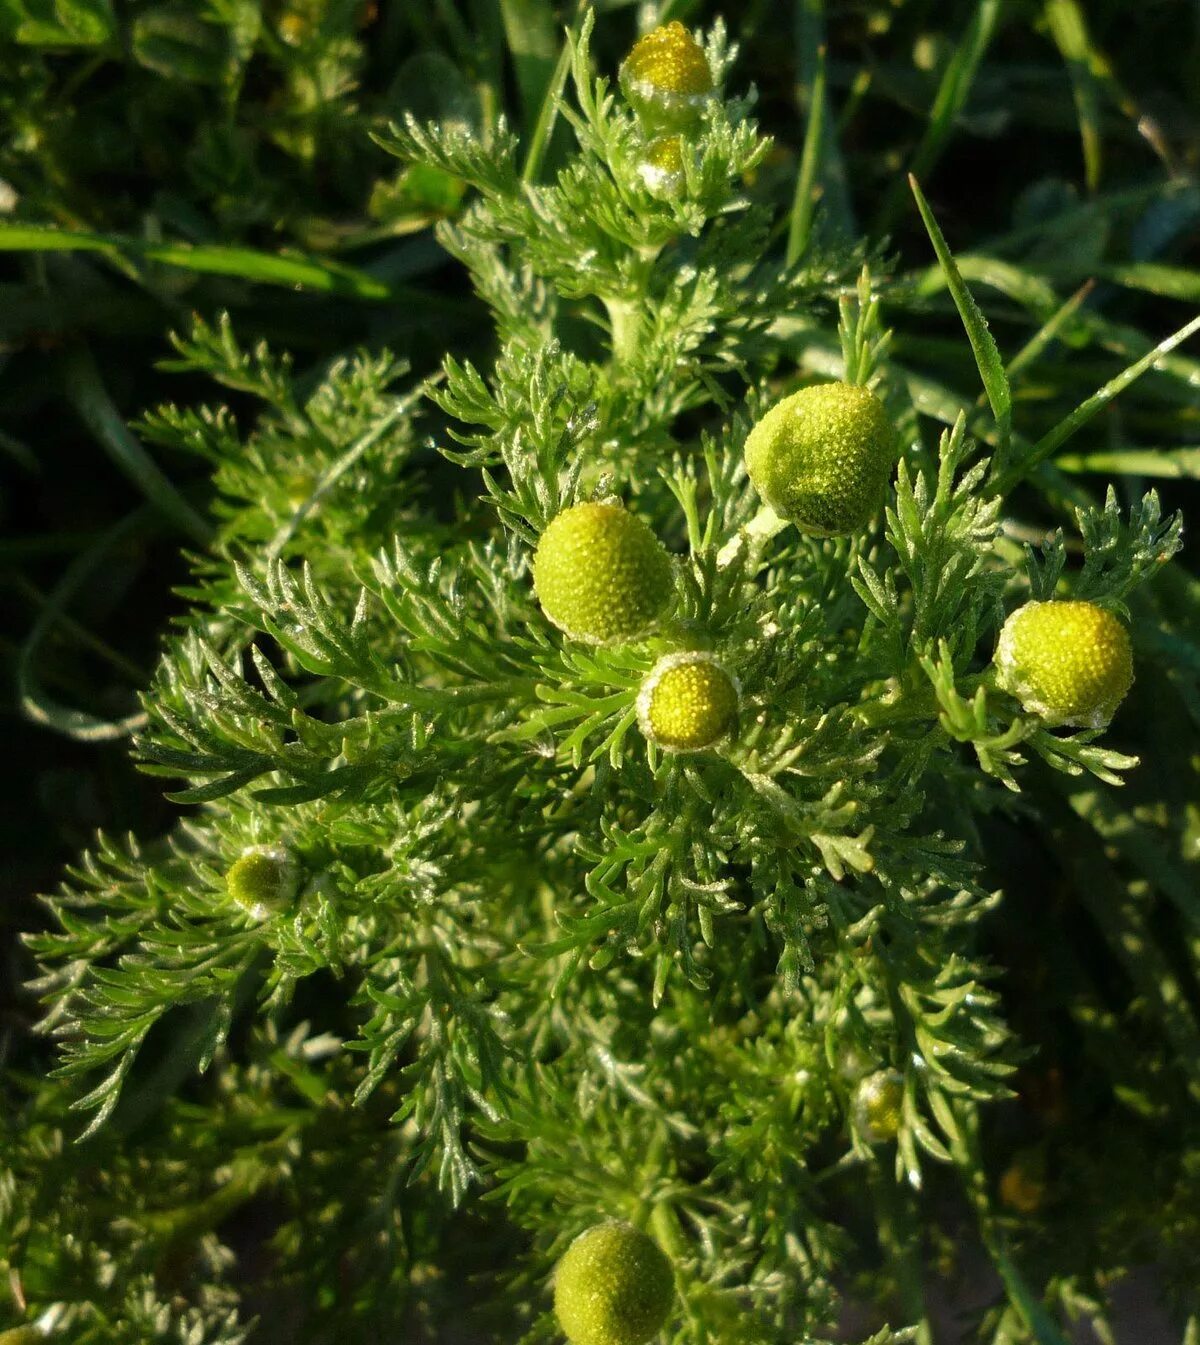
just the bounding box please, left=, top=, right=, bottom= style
left=533, top=504, right=674, bottom=644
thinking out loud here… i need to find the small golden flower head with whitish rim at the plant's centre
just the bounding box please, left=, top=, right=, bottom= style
left=638, top=650, right=739, bottom=752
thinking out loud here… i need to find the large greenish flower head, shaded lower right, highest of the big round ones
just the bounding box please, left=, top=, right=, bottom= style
left=745, top=383, right=896, bottom=537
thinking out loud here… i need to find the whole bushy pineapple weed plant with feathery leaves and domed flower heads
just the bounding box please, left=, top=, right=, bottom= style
left=0, top=7, right=1200, bottom=1345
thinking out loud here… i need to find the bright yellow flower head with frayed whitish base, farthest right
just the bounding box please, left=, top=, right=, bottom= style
left=996, top=603, right=1133, bottom=729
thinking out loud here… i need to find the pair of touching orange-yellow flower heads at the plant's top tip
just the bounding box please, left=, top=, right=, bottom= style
left=620, top=22, right=716, bottom=196
